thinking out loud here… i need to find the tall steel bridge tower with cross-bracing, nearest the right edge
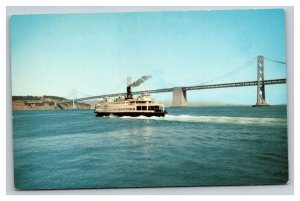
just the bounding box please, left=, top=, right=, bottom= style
left=253, top=55, right=269, bottom=107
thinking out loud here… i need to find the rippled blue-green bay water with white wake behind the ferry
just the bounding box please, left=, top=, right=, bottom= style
left=13, top=106, right=288, bottom=189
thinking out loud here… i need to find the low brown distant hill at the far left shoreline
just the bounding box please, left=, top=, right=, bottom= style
left=12, top=95, right=91, bottom=110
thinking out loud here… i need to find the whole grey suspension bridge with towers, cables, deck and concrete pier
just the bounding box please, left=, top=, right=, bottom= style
left=57, top=55, right=286, bottom=108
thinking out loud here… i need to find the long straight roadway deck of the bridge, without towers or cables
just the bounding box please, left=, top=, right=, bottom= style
left=59, top=79, right=286, bottom=103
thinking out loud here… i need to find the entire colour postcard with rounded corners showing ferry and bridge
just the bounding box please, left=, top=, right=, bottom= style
left=10, top=9, right=289, bottom=190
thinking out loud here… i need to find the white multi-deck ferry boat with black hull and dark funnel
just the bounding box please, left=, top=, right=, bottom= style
left=95, top=85, right=167, bottom=117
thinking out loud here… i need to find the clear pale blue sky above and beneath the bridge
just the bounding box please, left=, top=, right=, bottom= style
left=10, top=9, right=287, bottom=104
